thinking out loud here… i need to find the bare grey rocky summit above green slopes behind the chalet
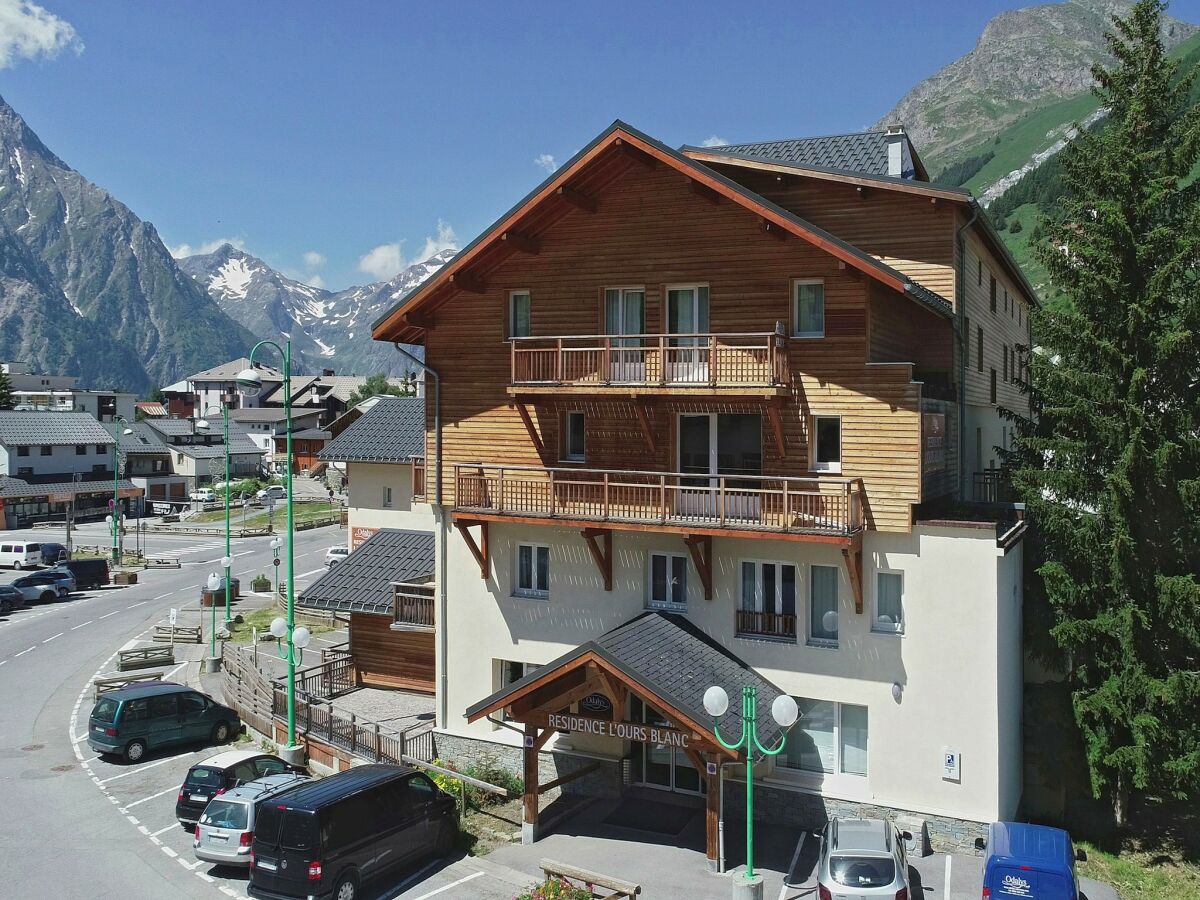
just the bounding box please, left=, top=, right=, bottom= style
left=878, top=0, right=1200, bottom=173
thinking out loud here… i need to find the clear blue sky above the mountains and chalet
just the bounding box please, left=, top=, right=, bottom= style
left=0, top=0, right=1200, bottom=288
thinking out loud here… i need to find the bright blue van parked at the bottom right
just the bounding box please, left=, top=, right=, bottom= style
left=976, top=822, right=1087, bottom=900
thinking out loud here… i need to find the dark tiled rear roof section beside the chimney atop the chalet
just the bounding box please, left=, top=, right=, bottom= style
left=684, top=131, right=929, bottom=181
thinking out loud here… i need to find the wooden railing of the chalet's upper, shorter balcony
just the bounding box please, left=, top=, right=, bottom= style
left=512, top=331, right=787, bottom=388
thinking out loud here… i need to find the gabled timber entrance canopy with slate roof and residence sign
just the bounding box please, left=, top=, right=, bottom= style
left=467, top=612, right=782, bottom=757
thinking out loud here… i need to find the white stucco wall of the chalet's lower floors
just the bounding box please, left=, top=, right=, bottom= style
left=439, top=523, right=1020, bottom=821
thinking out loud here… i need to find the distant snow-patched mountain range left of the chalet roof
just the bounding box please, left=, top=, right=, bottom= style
left=178, top=244, right=457, bottom=376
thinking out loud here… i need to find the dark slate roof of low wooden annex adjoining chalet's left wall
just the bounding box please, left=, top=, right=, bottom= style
left=296, top=528, right=433, bottom=616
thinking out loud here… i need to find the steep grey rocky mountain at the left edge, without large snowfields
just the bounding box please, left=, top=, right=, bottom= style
left=0, top=98, right=253, bottom=392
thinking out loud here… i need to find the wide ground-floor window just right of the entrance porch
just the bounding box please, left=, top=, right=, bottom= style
left=776, top=697, right=868, bottom=778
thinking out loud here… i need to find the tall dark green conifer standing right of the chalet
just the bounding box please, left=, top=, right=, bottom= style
left=1009, top=0, right=1200, bottom=824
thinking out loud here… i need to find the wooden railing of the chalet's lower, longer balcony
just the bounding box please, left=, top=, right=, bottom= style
left=455, top=464, right=863, bottom=535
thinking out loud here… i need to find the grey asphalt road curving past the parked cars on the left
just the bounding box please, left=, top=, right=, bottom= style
left=0, top=524, right=346, bottom=900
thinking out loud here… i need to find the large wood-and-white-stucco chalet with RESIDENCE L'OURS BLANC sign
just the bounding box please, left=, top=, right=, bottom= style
left=373, top=121, right=1038, bottom=869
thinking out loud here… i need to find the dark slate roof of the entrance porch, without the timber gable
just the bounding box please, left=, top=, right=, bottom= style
left=466, top=612, right=784, bottom=755
